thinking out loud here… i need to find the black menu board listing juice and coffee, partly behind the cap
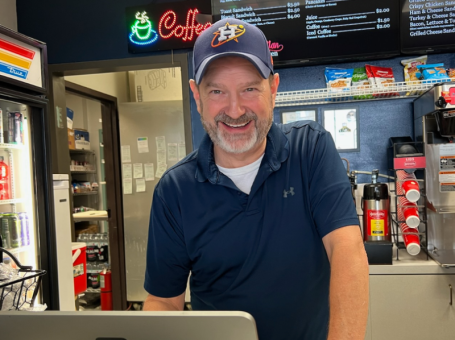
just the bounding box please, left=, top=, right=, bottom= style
left=212, top=0, right=400, bottom=65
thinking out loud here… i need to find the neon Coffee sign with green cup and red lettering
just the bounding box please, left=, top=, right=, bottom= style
left=126, top=0, right=211, bottom=53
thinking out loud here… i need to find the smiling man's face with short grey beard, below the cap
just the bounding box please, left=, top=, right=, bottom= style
left=190, top=57, right=279, bottom=154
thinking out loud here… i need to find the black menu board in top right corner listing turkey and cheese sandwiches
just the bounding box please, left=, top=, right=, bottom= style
left=401, top=0, right=455, bottom=53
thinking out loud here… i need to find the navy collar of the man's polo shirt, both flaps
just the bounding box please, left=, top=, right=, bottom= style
left=195, top=123, right=289, bottom=184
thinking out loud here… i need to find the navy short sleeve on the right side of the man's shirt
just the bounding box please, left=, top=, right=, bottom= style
left=309, top=130, right=359, bottom=238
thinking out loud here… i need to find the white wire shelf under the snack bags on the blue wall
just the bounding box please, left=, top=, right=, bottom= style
left=275, top=79, right=450, bottom=107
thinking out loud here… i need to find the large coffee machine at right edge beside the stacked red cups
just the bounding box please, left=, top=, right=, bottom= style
left=413, top=82, right=455, bottom=267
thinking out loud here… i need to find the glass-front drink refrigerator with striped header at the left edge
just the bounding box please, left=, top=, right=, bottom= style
left=0, top=26, right=58, bottom=309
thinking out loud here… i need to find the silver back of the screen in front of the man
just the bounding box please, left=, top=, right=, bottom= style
left=0, top=311, right=258, bottom=340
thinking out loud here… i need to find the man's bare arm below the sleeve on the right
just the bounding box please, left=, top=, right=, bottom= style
left=322, top=226, right=369, bottom=340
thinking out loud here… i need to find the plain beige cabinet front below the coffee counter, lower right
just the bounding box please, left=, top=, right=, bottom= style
left=365, top=275, right=455, bottom=340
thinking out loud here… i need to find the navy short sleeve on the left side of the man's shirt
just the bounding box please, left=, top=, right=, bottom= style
left=144, top=184, right=190, bottom=298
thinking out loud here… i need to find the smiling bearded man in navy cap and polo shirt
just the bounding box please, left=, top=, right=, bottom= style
left=144, top=19, right=368, bottom=340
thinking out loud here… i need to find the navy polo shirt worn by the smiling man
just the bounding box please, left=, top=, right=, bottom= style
left=144, top=122, right=359, bottom=340
